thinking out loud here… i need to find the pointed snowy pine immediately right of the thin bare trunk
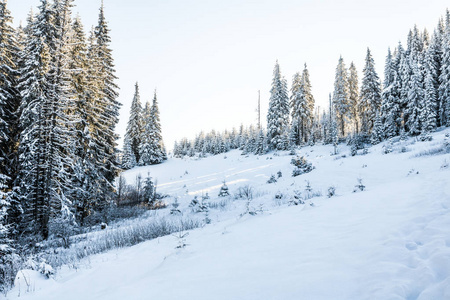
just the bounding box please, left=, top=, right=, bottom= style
left=267, top=61, right=289, bottom=150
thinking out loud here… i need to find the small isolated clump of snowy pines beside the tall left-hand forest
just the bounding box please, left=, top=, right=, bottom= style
left=122, top=83, right=167, bottom=170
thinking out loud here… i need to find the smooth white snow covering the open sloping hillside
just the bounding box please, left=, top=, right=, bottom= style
left=0, top=130, right=450, bottom=300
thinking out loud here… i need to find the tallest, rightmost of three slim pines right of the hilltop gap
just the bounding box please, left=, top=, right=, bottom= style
left=358, top=48, right=381, bottom=134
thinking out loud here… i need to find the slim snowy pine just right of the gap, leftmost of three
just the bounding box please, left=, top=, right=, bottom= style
left=333, top=56, right=350, bottom=137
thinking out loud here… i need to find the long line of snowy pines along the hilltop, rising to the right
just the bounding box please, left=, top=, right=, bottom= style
left=174, top=10, right=450, bottom=156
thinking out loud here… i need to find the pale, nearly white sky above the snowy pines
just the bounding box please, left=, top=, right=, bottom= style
left=8, top=0, right=449, bottom=148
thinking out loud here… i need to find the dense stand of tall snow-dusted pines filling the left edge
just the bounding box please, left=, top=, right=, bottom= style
left=0, top=0, right=120, bottom=262
